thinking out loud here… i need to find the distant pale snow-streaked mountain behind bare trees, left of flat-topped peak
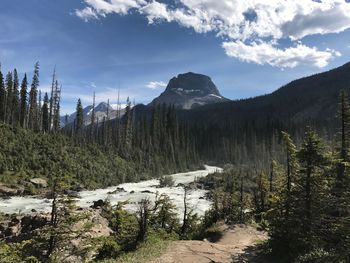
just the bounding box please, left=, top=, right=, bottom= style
left=61, top=102, right=124, bottom=127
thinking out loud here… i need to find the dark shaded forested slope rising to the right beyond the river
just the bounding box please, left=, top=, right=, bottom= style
left=178, top=63, right=350, bottom=168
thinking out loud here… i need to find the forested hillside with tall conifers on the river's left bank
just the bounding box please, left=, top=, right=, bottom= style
left=0, top=63, right=200, bottom=192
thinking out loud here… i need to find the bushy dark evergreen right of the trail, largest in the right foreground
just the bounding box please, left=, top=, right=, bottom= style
left=295, top=128, right=331, bottom=247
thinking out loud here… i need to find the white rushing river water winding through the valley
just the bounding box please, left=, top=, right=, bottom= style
left=0, top=166, right=222, bottom=218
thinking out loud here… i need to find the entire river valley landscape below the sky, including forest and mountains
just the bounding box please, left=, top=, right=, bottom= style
left=0, top=58, right=350, bottom=263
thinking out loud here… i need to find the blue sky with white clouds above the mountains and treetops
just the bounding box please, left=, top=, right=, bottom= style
left=0, top=0, right=350, bottom=114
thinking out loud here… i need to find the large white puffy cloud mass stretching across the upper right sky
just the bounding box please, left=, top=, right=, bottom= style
left=76, top=0, right=350, bottom=67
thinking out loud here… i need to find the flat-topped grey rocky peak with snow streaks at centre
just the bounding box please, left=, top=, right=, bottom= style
left=151, top=72, right=228, bottom=109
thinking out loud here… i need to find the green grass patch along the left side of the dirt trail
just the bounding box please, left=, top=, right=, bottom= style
left=99, top=234, right=170, bottom=263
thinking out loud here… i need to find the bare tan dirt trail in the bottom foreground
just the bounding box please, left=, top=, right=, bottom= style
left=152, top=225, right=267, bottom=263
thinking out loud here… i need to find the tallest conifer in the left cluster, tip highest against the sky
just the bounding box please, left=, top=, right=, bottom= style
left=28, top=62, right=39, bottom=131
